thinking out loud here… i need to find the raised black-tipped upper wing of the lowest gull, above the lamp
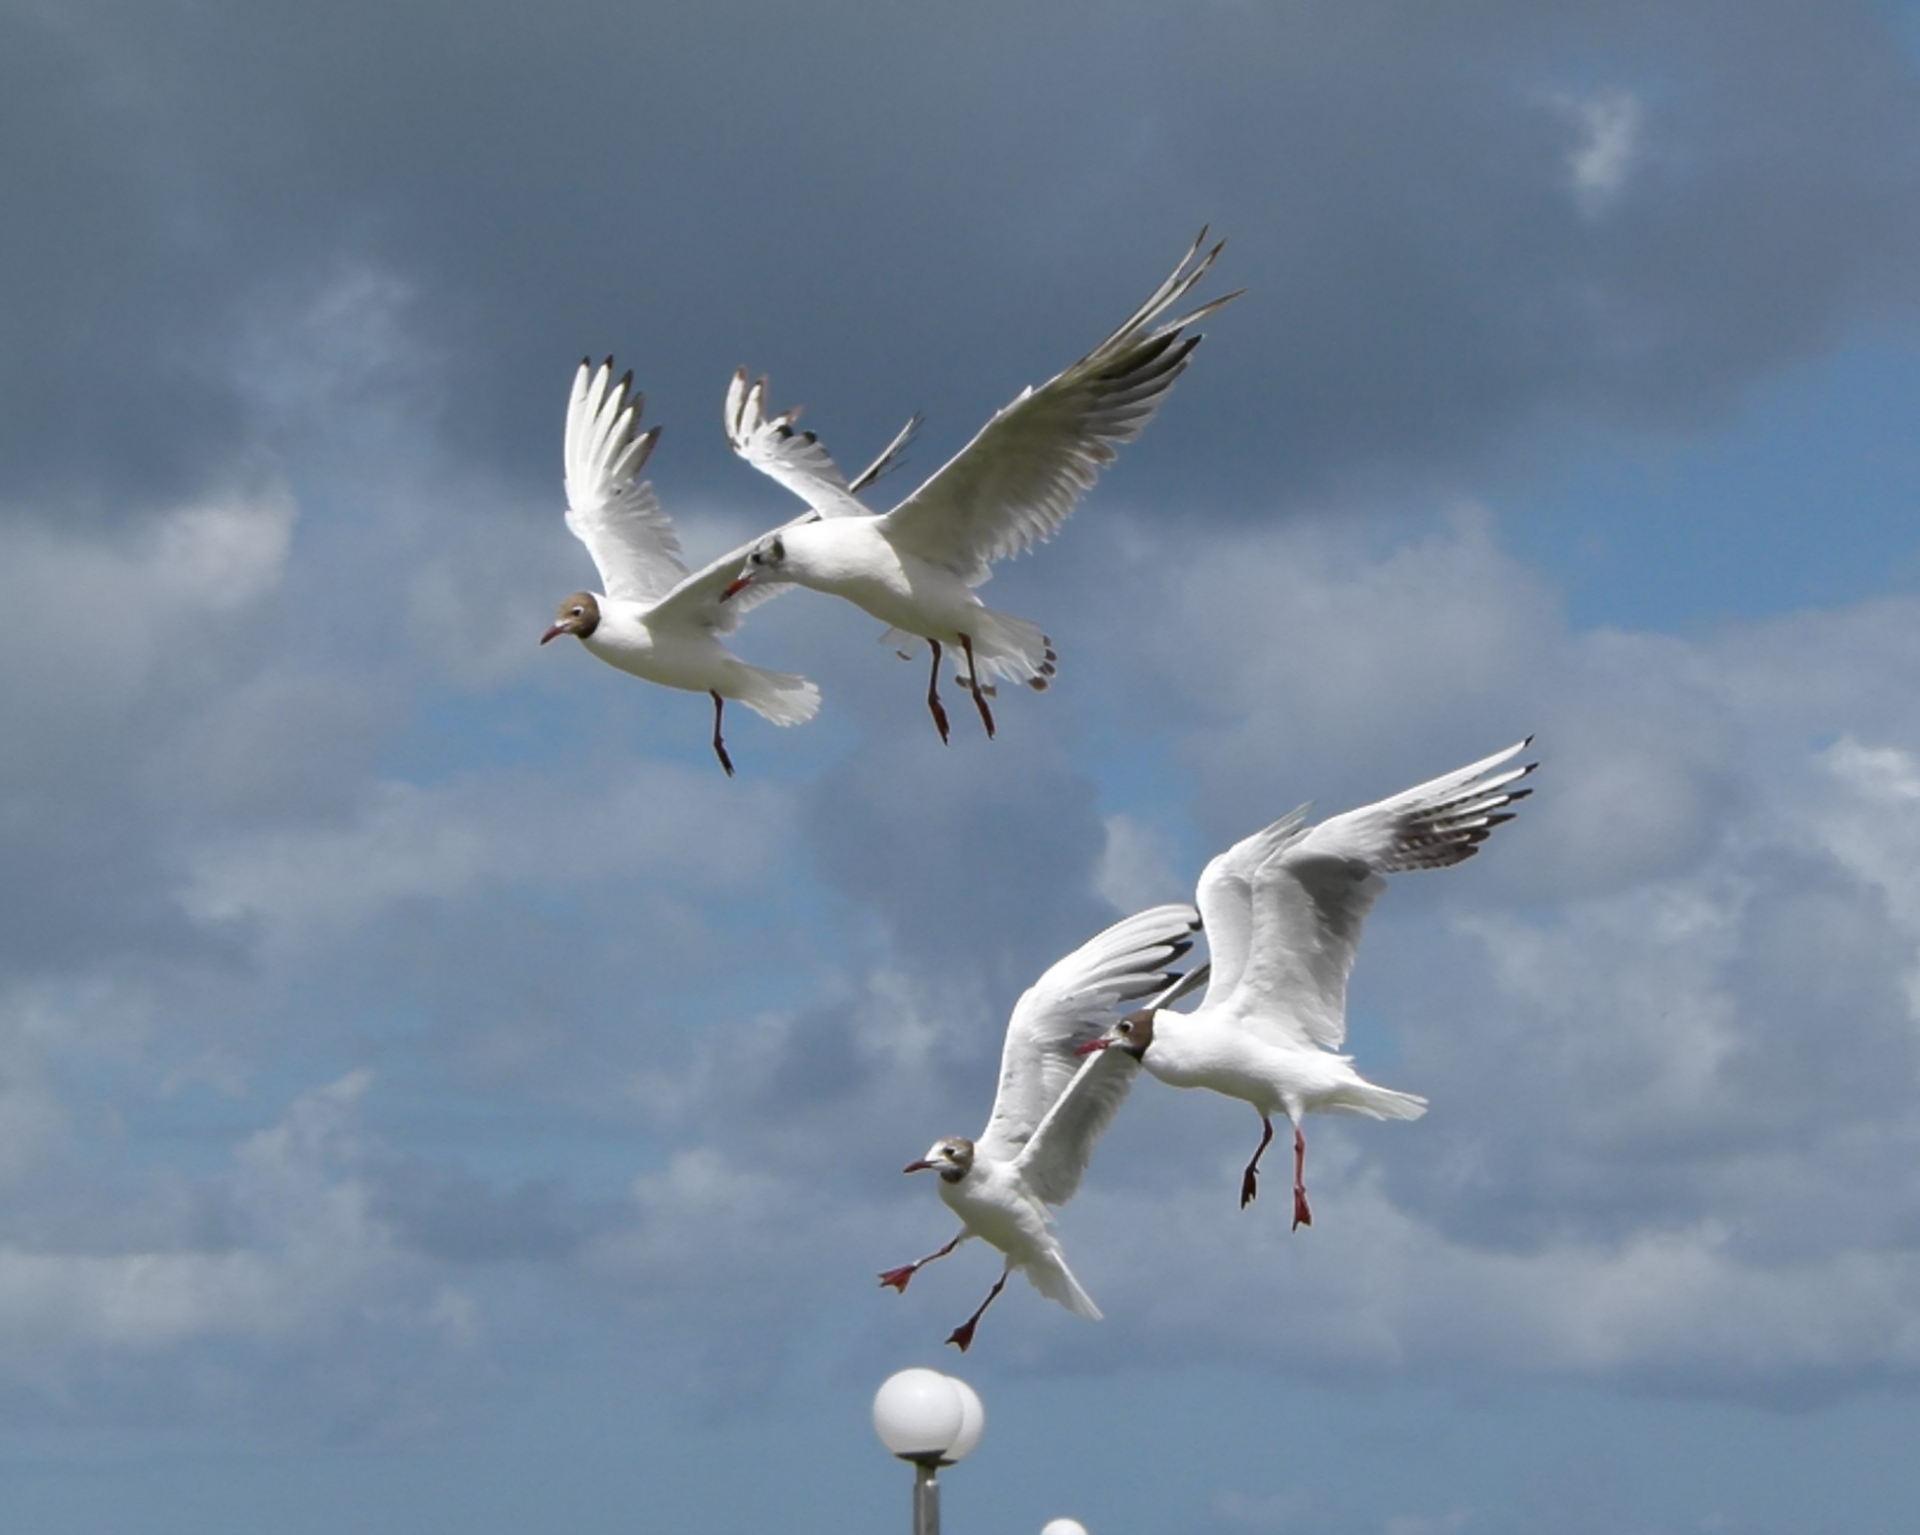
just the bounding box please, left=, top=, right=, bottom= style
left=979, top=905, right=1200, bottom=1158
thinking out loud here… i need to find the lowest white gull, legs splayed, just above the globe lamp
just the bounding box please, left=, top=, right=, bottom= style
left=879, top=905, right=1200, bottom=1352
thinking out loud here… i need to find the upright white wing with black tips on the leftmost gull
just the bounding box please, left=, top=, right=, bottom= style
left=566, top=357, right=687, bottom=603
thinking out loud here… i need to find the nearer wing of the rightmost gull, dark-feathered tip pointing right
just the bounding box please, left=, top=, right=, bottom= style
left=1227, top=736, right=1536, bottom=1049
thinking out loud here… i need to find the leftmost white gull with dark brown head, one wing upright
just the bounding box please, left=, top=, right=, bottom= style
left=540, top=359, right=820, bottom=776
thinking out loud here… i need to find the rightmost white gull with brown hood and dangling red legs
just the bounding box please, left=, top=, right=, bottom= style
left=1087, top=738, right=1536, bottom=1228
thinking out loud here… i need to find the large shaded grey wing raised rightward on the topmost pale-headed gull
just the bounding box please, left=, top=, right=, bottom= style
left=881, top=229, right=1238, bottom=586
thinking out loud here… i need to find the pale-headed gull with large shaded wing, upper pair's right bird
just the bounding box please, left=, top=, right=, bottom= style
left=726, top=231, right=1238, bottom=740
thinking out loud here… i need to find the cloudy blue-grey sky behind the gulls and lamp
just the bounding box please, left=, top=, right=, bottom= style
left=11, top=0, right=1920, bottom=1535
